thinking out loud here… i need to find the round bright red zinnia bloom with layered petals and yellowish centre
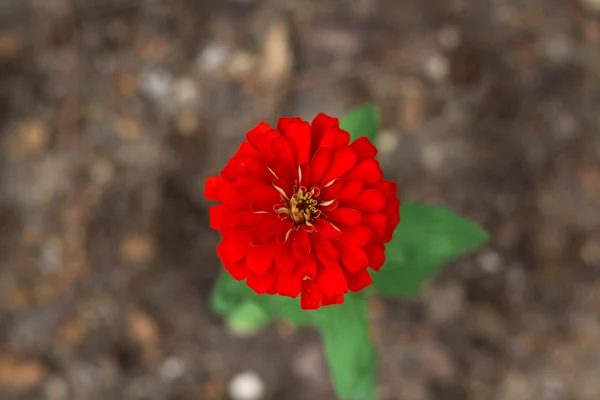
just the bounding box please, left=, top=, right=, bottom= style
left=205, top=114, right=400, bottom=309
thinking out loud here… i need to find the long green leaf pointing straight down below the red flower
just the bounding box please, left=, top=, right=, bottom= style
left=310, top=293, right=377, bottom=400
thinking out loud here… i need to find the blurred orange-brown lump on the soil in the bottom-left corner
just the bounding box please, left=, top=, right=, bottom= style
left=0, top=359, right=48, bottom=390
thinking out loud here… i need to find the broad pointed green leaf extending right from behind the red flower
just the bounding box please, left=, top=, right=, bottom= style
left=371, top=203, right=489, bottom=296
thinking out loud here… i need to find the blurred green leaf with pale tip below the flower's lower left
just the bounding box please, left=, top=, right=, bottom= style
left=210, top=270, right=309, bottom=327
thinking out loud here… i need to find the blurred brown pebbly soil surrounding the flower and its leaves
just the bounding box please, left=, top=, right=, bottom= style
left=0, top=0, right=600, bottom=400
